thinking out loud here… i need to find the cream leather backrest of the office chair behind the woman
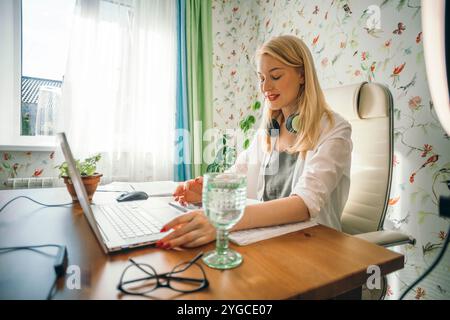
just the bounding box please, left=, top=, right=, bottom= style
left=324, top=82, right=393, bottom=234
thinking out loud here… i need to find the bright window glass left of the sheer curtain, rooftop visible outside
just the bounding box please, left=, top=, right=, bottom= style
left=20, top=0, right=76, bottom=136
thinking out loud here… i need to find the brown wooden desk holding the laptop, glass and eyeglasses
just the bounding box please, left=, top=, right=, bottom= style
left=0, top=188, right=404, bottom=299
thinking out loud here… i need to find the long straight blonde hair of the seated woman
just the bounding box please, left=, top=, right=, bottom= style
left=256, top=35, right=334, bottom=159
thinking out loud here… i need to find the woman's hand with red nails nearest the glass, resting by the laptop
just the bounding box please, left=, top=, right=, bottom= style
left=156, top=210, right=216, bottom=249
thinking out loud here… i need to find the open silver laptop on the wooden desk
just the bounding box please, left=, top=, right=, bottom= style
left=57, top=133, right=181, bottom=253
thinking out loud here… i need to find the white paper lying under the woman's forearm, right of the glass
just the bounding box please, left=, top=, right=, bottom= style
left=230, top=220, right=317, bottom=246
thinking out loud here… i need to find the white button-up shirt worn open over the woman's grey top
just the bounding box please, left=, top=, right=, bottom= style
left=228, top=112, right=353, bottom=230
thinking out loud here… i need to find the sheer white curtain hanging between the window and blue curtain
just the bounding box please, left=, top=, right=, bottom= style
left=59, top=0, right=177, bottom=182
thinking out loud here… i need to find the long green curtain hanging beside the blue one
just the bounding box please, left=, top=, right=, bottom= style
left=186, top=0, right=213, bottom=177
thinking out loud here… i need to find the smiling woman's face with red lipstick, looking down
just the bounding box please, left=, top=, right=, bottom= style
left=258, top=54, right=305, bottom=110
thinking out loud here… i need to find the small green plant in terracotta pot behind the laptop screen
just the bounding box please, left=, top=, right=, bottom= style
left=55, top=154, right=103, bottom=202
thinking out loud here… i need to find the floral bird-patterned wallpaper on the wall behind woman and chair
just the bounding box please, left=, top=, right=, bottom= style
left=213, top=0, right=450, bottom=299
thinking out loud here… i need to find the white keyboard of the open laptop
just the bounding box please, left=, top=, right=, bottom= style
left=99, top=204, right=163, bottom=239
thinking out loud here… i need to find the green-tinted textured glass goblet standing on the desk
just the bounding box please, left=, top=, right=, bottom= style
left=202, top=173, right=247, bottom=269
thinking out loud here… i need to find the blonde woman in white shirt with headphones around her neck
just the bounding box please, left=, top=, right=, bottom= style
left=157, top=35, right=352, bottom=249
